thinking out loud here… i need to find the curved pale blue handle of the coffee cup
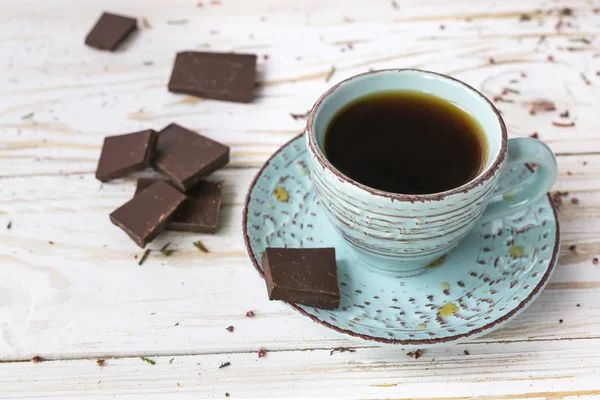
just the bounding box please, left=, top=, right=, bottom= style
left=482, top=138, right=557, bottom=221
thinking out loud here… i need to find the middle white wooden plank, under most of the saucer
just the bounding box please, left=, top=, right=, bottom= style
left=0, top=155, right=600, bottom=360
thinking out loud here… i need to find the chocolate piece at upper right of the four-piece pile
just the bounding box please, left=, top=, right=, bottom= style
left=154, top=124, right=229, bottom=192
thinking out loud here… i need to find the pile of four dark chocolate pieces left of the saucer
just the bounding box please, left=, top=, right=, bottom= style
left=96, top=124, right=229, bottom=248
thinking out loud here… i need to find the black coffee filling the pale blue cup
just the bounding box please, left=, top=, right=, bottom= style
left=325, top=91, right=487, bottom=194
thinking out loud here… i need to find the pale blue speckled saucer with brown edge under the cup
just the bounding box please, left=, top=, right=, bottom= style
left=243, top=135, right=559, bottom=348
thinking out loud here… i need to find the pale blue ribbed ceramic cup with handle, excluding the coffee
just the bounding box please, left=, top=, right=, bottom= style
left=306, top=69, right=557, bottom=276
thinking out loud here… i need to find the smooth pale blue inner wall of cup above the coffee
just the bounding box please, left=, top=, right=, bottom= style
left=308, top=70, right=506, bottom=191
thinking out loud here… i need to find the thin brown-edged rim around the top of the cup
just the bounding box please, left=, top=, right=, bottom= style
left=306, top=68, right=508, bottom=203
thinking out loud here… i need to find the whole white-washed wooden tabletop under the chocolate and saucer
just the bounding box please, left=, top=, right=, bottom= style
left=0, top=0, right=600, bottom=399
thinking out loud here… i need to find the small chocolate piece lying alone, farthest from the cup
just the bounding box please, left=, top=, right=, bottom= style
left=85, top=12, right=137, bottom=51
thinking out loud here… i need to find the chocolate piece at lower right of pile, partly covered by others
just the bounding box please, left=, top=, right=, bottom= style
left=135, top=178, right=221, bottom=233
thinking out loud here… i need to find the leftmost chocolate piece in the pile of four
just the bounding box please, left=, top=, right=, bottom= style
left=96, top=129, right=158, bottom=182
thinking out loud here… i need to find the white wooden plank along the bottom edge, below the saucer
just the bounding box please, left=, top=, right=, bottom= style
left=0, top=339, right=600, bottom=399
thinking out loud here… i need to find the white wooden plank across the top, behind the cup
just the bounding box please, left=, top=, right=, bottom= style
left=0, top=0, right=600, bottom=176
